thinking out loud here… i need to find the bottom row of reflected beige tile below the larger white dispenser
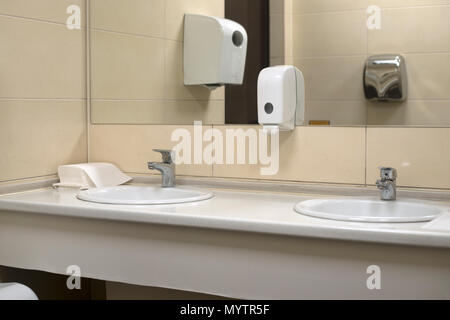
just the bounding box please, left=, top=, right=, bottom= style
left=91, top=100, right=225, bottom=124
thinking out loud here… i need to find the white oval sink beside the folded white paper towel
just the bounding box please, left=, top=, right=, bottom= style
left=77, top=186, right=214, bottom=205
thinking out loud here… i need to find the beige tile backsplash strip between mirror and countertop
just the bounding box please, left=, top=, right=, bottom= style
left=91, top=125, right=450, bottom=189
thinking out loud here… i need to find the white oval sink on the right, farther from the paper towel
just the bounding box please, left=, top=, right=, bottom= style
left=295, top=198, right=443, bottom=223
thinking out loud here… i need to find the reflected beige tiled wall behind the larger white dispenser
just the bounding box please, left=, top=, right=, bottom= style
left=90, top=0, right=225, bottom=124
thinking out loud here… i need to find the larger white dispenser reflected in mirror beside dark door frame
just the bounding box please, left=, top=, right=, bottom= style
left=184, top=14, right=248, bottom=89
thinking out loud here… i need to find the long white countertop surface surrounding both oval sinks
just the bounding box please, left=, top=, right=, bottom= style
left=0, top=184, right=450, bottom=248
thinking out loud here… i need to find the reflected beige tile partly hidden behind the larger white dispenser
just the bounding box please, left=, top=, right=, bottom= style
left=164, top=40, right=225, bottom=100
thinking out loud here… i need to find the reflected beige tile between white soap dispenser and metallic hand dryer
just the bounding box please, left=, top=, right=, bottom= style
left=294, top=56, right=366, bottom=101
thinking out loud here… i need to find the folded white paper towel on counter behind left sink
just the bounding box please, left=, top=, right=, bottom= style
left=54, top=163, right=132, bottom=189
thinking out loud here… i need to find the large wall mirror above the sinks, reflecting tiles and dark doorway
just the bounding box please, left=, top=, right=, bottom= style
left=89, top=0, right=450, bottom=127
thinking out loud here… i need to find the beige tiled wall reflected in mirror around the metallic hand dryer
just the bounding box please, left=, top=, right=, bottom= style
left=285, top=0, right=450, bottom=126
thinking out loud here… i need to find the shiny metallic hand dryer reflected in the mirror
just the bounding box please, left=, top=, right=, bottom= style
left=364, top=54, right=407, bottom=101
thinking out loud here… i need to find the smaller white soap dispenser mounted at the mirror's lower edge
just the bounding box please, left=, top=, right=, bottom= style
left=258, top=66, right=305, bottom=131
